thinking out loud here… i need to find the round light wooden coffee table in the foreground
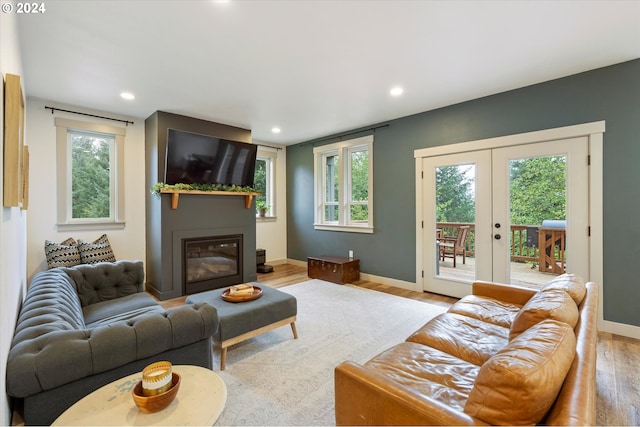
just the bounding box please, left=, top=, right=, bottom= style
left=52, top=365, right=227, bottom=426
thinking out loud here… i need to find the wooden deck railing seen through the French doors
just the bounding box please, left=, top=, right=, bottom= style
left=436, top=222, right=566, bottom=274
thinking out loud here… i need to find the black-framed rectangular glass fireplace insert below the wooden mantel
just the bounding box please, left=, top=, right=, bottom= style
left=182, top=234, right=243, bottom=295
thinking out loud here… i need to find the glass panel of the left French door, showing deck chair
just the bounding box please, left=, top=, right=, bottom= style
left=434, top=164, right=476, bottom=282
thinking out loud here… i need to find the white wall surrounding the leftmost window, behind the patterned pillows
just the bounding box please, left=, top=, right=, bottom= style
left=27, top=98, right=149, bottom=279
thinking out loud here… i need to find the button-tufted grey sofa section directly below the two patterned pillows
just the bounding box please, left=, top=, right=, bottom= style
left=62, top=261, right=144, bottom=307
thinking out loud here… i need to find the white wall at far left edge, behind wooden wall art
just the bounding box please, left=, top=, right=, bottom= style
left=0, top=3, right=29, bottom=425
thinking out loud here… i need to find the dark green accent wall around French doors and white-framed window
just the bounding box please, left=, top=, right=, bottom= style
left=287, top=59, right=640, bottom=326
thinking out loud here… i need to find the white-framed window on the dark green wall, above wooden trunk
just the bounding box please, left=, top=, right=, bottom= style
left=313, top=135, right=373, bottom=233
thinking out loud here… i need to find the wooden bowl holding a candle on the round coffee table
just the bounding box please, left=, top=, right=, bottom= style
left=131, top=362, right=180, bottom=413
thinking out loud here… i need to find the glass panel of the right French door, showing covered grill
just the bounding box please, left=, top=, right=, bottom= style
left=509, top=155, right=567, bottom=287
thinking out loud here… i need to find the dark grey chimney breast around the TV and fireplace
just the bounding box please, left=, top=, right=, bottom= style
left=144, top=111, right=258, bottom=301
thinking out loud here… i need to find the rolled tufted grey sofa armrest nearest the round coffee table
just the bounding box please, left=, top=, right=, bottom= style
left=6, top=304, right=218, bottom=397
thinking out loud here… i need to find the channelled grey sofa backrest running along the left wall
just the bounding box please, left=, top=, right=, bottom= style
left=13, top=268, right=85, bottom=347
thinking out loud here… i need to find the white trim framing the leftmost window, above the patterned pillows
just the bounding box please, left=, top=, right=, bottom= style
left=54, top=117, right=127, bottom=230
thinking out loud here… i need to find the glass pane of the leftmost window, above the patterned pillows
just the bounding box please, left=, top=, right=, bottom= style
left=69, top=132, right=115, bottom=218
